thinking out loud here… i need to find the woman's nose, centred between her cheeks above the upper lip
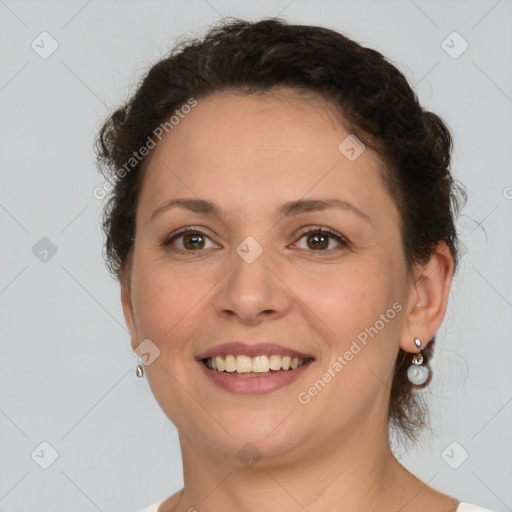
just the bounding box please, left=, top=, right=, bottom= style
left=215, top=241, right=291, bottom=324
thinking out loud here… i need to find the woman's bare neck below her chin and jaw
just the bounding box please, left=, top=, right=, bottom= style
left=174, top=418, right=417, bottom=512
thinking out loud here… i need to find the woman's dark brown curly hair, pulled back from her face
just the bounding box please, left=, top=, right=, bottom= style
left=96, top=18, right=466, bottom=440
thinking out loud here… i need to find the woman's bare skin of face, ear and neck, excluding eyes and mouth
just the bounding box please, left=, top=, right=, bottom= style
left=121, top=89, right=458, bottom=512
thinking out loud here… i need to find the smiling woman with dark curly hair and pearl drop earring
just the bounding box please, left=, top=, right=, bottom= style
left=98, top=19, right=496, bottom=512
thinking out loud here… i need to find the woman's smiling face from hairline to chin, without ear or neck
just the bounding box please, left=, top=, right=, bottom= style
left=122, top=92, right=414, bottom=462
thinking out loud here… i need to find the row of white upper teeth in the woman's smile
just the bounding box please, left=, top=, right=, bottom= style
left=206, top=354, right=304, bottom=374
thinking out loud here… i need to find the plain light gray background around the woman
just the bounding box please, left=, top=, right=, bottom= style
left=0, top=0, right=512, bottom=512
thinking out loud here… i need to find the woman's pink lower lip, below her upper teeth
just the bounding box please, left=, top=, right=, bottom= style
left=198, top=359, right=313, bottom=395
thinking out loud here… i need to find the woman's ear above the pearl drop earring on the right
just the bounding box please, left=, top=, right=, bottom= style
left=400, top=242, right=454, bottom=352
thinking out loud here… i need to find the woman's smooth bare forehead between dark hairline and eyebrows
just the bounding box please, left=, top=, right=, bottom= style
left=136, top=91, right=396, bottom=226
